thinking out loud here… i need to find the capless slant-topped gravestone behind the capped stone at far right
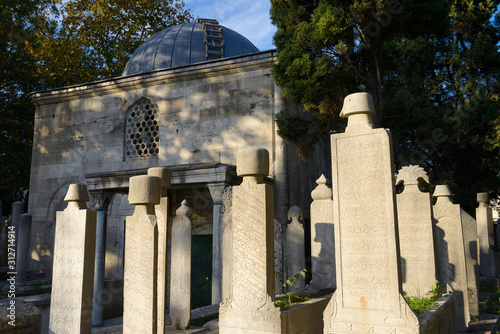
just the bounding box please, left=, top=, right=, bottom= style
left=460, top=209, right=480, bottom=316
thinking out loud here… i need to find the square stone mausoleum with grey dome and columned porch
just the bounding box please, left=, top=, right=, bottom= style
left=28, top=19, right=331, bottom=308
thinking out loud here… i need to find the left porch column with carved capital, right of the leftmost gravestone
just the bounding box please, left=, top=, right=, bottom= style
left=90, top=192, right=113, bottom=327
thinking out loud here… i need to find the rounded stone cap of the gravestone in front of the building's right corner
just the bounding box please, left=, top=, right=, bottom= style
left=236, top=147, right=269, bottom=181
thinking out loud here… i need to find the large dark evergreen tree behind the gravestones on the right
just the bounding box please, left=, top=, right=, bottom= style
left=271, top=0, right=500, bottom=209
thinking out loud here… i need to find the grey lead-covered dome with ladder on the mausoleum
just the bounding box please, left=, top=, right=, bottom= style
left=122, top=19, right=259, bottom=76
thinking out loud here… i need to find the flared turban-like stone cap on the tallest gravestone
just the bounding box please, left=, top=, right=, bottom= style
left=340, top=93, right=375, bottom=132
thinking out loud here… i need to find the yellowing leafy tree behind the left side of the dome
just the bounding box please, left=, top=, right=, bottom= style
left=32, top=0, right=192, bottom=88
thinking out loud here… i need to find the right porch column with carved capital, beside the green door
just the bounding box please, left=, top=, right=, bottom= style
left=207, top=183, right=226, bottom=304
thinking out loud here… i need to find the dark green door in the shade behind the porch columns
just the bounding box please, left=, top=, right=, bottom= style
left=191, top=234, right=212, bottom=309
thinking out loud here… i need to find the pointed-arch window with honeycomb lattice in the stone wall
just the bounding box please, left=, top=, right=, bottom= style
left=126, top=98, right=160, bottom=160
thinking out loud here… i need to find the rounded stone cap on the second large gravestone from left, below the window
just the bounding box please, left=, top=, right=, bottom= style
left=128, top=175, right=161, bottom=205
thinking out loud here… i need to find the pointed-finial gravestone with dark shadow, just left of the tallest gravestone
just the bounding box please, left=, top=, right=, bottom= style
left=311, top=175, right=336, bottom=290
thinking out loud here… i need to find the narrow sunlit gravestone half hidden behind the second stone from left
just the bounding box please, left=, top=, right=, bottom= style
left=148, top=167, right=172, bottom=334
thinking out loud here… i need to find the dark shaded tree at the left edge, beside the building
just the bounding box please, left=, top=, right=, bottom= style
left=0, top=0, right=56, bottom=209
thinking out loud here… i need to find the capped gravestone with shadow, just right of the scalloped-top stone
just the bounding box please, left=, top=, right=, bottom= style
left=433, top=185, right=470, bottom=331
